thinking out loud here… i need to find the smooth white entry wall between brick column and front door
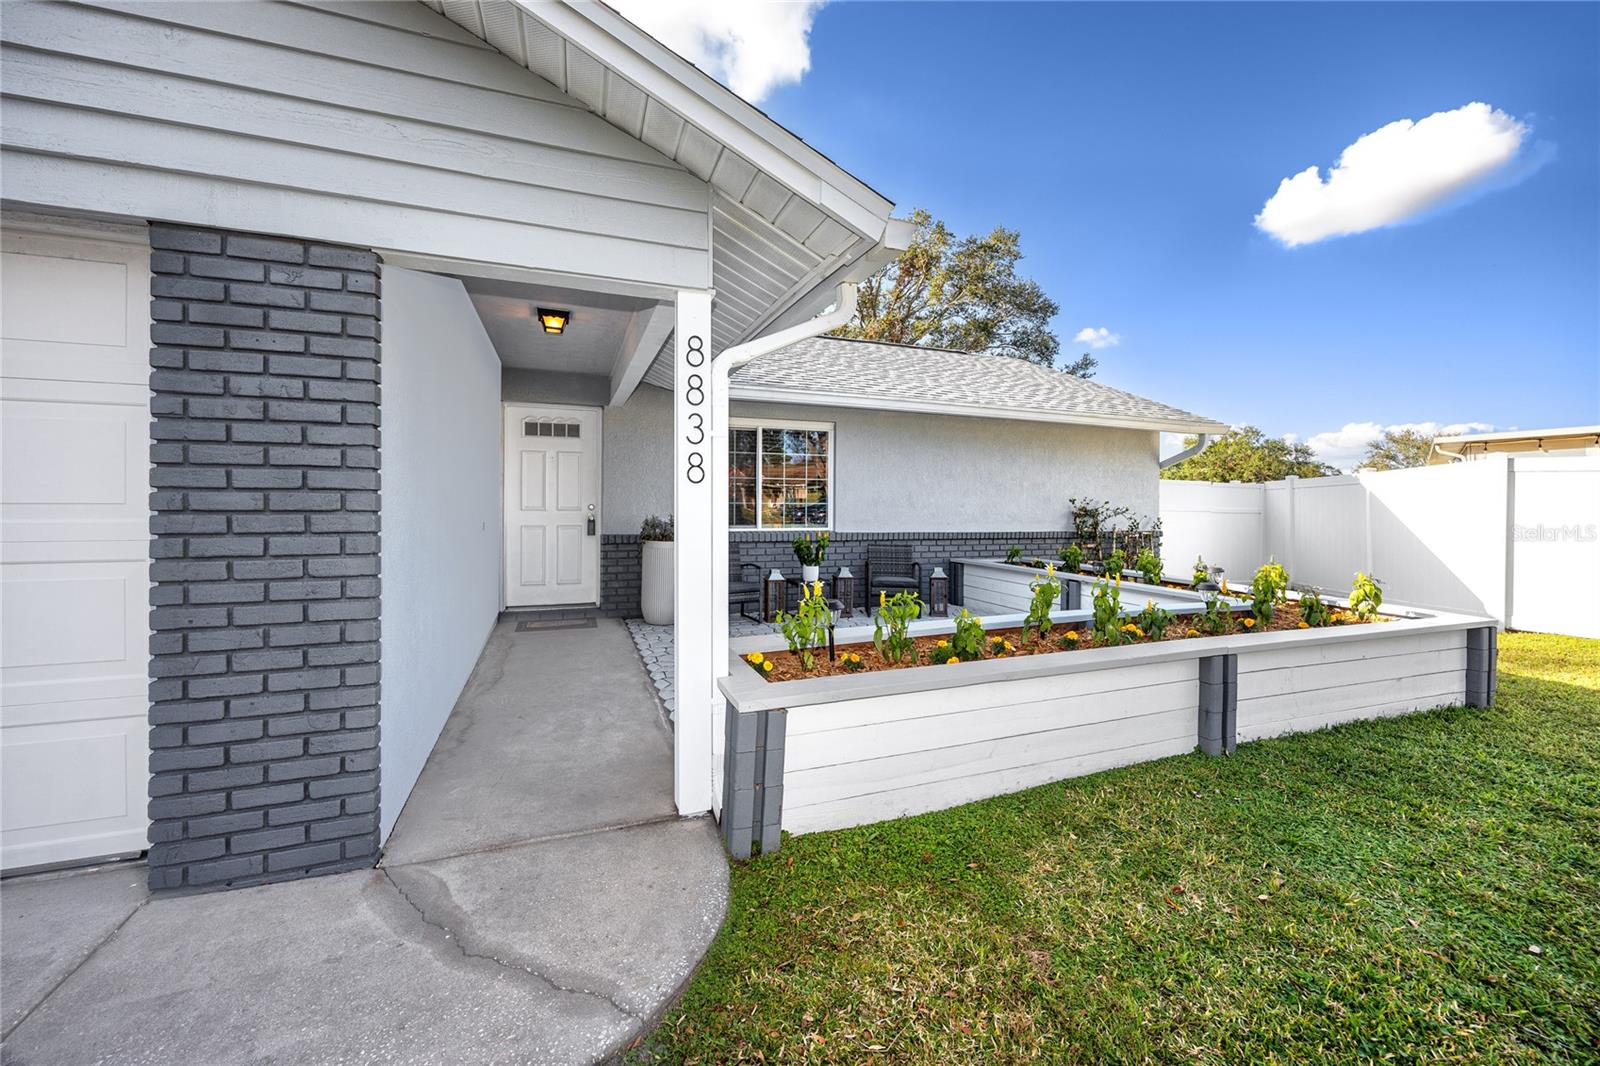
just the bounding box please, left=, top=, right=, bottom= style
left=381, top=267, right=501, bottom=837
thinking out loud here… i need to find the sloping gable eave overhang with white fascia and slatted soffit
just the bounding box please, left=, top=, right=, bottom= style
left=422, top=0, right=910, bottom=349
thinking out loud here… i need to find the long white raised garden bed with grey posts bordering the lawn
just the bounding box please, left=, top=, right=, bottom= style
left=718, top=583, right=1494, bottom=855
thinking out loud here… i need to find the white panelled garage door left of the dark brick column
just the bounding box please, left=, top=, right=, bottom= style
left=0, top=226, right=150, bottom=869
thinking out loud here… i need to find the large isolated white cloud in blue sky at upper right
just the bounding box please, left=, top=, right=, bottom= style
left=1256, top=102, right=1542, bottom=248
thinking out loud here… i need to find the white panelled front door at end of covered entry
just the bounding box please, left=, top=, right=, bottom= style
left=504, top=403, right=600, bottom=607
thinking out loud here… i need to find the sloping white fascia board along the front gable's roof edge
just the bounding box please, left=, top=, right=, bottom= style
left=528, top=0, right=894, bottom=238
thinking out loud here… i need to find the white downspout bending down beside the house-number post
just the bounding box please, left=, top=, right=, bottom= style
left=710, top=282, right=856, bottom=808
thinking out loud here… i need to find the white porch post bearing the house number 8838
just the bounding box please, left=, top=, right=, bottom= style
left=672, top=291, right=716, bottom=815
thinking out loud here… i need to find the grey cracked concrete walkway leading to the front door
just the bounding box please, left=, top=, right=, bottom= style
left=0, top=619, right=728, bottom=1066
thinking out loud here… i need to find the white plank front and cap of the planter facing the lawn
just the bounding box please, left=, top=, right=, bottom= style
left=723, top=615, right=1493, bottom=832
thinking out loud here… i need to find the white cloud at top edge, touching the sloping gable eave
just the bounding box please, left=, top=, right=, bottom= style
left=611, top=0, right=824, bottom=104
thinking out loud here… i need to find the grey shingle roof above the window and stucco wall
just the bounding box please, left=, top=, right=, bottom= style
left=730, top=336, right=1229, bottom=434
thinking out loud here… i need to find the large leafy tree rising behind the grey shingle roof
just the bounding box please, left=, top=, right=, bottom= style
left=834, top=208, right=1096, bottom=378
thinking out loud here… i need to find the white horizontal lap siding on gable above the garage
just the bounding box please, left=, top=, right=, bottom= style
left=0, top=0, right=710, bottom=288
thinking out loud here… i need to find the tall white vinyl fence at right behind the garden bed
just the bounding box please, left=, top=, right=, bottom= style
left=1160, top=456, right=1600, bottom=637
